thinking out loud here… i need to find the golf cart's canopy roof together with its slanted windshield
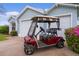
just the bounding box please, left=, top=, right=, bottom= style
left=28, top=16, right=60, bottom=36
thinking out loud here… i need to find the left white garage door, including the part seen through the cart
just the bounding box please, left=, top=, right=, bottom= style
left=20, top=21, right=46, bottom=37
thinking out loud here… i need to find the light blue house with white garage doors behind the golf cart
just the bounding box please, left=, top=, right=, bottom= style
left=9, top=4, right=79, bottom=37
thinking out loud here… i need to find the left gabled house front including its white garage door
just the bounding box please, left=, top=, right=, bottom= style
left=17, top=9, right=42, bottom=37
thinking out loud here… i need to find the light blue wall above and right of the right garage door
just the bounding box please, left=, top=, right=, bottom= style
left=48, top=6, right=77, bottom=27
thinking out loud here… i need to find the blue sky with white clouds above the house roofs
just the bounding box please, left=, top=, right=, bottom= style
left=0, top=3, right=53, bottom=25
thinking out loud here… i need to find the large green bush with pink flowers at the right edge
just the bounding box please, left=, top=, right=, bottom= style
left=65, top=26, right=79, bottom=53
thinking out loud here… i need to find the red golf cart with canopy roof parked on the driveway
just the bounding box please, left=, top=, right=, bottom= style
left=24, top=16, right=64, bottom=55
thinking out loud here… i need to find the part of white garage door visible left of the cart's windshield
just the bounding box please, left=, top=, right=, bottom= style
left=20, top=21, right=31, bottom=37
